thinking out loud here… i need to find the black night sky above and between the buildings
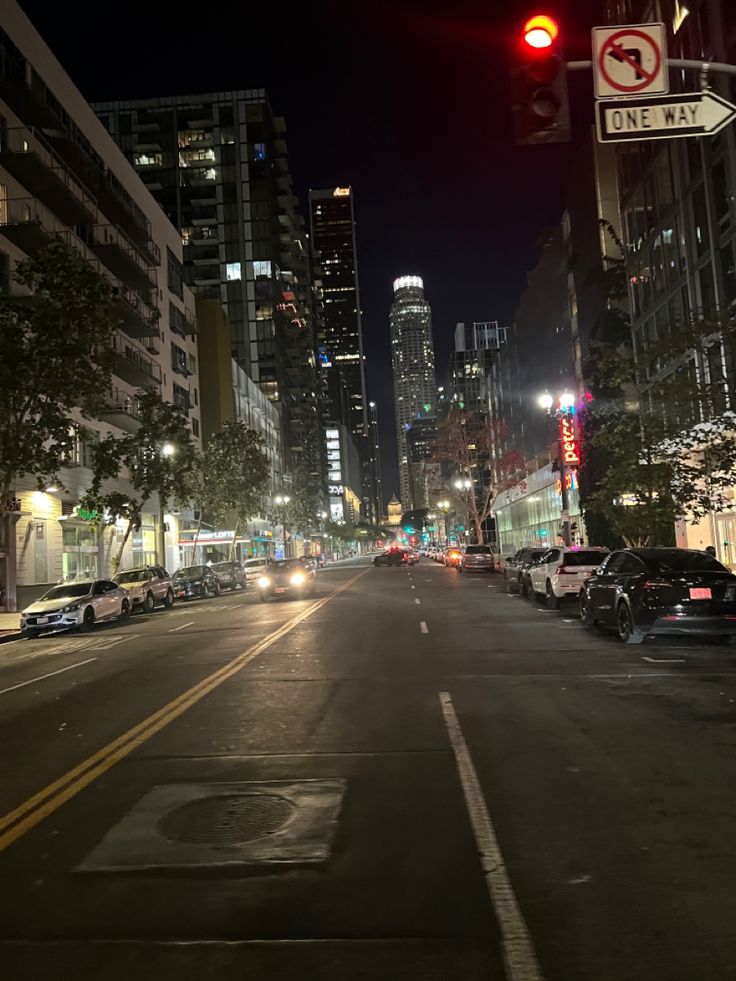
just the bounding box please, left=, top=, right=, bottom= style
left=21, top=0, right=601, bottom=497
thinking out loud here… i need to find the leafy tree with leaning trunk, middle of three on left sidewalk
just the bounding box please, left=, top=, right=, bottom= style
left=82, top=391, right=195, bottom=570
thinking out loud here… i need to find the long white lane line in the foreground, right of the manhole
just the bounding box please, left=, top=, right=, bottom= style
left=439, top=691, right=543, bottom=981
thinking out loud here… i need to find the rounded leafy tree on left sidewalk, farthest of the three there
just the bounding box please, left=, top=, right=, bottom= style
left=194, top=421, right=270, bottom=552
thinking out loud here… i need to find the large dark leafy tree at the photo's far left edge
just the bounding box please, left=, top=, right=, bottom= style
left=0, top=241, right=117, bottom=508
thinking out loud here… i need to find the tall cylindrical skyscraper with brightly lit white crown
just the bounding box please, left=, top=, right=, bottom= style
left=389, top=276, right=437, bottom=510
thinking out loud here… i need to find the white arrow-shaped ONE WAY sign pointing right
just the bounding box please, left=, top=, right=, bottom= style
left=595, top=92, right=736, bottom=143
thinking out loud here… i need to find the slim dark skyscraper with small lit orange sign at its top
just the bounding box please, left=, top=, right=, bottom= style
left=309, top=187, right=368, bottom=436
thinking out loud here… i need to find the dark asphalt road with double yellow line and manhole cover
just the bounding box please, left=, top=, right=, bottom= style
left=0, top=560, right=736, bottom=981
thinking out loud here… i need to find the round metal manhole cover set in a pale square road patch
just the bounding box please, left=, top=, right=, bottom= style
left=157, top=794, right=294, bottom=845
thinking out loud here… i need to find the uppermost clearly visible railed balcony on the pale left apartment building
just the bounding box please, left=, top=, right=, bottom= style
left=0, top=127, right=97, bottom=225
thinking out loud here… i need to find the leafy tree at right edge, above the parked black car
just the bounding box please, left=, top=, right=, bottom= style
left=582, top=319, right=736, bottom=545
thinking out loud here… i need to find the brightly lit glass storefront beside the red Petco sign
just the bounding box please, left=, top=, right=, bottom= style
left=492, top=463, right=583, bottom=555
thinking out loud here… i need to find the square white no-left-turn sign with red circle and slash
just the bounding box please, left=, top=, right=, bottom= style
left=592, top=24, right=670, bottom=99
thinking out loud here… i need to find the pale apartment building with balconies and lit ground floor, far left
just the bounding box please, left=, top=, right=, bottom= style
left=0, top=0, right=200, bottom=609
